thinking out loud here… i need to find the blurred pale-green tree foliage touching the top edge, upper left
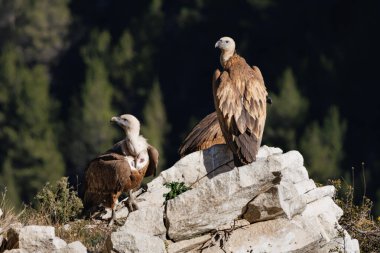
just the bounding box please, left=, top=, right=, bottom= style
left=15, top=0, right=71, bottom=64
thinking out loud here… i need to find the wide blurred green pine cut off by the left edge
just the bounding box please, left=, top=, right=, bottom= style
left=0, top=45, right=64, bottom=206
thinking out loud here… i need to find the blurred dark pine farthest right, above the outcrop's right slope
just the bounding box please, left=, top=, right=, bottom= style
left=300, top=106, right=347, bottom=182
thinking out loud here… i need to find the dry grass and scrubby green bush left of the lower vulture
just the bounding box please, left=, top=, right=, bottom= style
left=0, top=178, right=115, bottom=252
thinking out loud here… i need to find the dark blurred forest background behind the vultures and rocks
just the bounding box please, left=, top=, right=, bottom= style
left=0, top=0, right=380, bottom=213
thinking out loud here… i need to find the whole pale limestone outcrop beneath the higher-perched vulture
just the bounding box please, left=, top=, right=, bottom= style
left=105, top=145, right=359, bottom=253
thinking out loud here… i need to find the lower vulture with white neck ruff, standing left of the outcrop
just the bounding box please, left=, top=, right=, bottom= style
left=84, top=114, right=158, bottom=225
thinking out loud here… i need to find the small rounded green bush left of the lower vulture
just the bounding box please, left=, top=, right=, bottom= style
left=27, top=177, right=83, bottom=224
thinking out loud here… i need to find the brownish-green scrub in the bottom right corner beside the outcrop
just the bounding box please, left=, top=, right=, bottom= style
left=330, top=180, right=380, bottom=252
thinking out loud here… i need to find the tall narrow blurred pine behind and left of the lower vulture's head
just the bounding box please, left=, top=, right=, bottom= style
left=65, top=31, right=115, bottom=175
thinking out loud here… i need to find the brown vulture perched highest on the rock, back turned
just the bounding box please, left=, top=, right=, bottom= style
left=212, top=37, right=268, bottom=166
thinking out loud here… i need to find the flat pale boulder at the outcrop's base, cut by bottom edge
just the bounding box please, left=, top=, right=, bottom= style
left=203, top=216, right=324, bottom=253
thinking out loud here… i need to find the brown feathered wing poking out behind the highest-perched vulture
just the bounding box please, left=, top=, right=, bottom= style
left=179, top=112, right=226, bottom=157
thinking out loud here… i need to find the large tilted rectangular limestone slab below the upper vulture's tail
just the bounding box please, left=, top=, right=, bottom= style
left=166, top=159, right=279, bottom=241
